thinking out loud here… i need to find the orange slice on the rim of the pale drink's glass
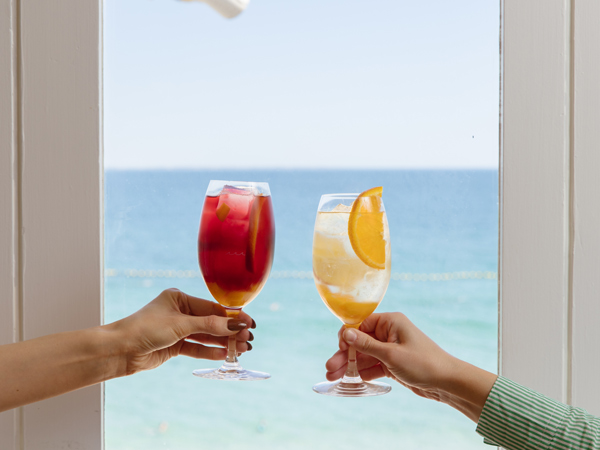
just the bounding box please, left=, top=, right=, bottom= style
left=348, top=186, right=386, bottom=269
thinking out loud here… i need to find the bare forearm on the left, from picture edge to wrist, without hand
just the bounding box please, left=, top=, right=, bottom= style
left=0, top=327, right=120, bottom=411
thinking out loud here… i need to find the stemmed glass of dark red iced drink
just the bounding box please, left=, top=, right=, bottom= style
left=193, top=180, right=275, bottom=381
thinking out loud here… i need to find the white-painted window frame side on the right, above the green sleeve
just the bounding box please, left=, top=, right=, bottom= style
left=499, top=0, right=600, bottom=415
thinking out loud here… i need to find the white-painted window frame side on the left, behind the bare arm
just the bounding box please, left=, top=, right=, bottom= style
left=0, top=0, right=104, bottom=450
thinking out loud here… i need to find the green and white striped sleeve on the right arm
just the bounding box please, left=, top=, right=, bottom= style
left=477, top=377, right=600, bottom=450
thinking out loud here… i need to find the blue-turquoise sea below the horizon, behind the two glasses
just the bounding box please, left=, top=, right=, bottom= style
left=104, top=170, right=498, bottom=450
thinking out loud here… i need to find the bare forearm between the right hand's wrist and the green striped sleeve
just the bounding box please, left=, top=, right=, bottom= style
left=440, top=358, right=498, bottom=423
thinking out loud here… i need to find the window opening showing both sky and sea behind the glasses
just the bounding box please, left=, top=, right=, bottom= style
left=104, top=0, right=499, bottom=450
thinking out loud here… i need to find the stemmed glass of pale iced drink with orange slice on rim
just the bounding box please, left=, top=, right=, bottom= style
left=313, top=192, right=392, bottom=397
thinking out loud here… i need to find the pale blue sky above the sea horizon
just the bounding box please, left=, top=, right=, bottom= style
left=104, top=0, right=499, bottom=169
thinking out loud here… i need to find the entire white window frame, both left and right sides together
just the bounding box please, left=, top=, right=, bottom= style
left=0, top=0, right=600, bottom=450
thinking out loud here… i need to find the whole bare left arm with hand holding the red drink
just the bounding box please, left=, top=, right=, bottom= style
left=0, top=289, right=253, bottom=411
